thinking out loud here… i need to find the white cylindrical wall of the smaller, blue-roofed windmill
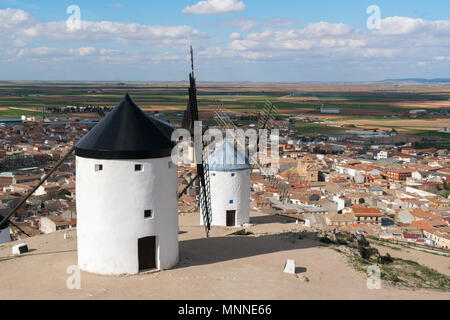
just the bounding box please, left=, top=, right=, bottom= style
left=200, top=169, right=250, bottom=226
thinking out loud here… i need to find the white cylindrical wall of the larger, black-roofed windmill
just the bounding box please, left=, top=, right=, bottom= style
left=76, top=157, right=178, bottom=274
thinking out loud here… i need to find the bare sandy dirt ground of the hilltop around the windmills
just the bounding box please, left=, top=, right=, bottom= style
left=0, top=213, right=450, bottom=300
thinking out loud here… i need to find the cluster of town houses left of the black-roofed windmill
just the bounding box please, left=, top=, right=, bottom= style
left=0, top=122, right=90, bottom=240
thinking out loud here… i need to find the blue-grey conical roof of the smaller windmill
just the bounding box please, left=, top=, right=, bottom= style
left=208, top=140, right=250, bottom=171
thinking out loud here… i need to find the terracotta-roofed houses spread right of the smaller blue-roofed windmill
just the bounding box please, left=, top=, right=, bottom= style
left=253, top=143, right=450, bottom=249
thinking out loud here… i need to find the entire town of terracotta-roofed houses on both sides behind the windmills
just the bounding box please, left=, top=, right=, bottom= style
left=0, top=117, right=450, bottom=249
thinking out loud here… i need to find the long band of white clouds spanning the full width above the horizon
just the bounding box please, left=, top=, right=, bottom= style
left=0, top=8, right=450, bottom=77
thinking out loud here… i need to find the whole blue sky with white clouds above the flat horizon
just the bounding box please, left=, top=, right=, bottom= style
left=0, top=0, right=450, bottom=82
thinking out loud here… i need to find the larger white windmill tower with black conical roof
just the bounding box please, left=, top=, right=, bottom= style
left=75, top=95, right=179, bottom=275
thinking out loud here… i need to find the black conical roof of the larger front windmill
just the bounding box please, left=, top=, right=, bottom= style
left=75, top=94, right=175, bottom=159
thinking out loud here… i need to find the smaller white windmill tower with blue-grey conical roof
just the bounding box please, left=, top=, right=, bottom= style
left=200, top=140, right=250, bottom=226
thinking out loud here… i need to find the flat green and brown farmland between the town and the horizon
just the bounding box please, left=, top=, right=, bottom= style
left=0, top=82, right=450, bottom=138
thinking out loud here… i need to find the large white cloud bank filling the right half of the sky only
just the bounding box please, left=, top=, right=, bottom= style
left=223, top=17, right=450, bottom=66
